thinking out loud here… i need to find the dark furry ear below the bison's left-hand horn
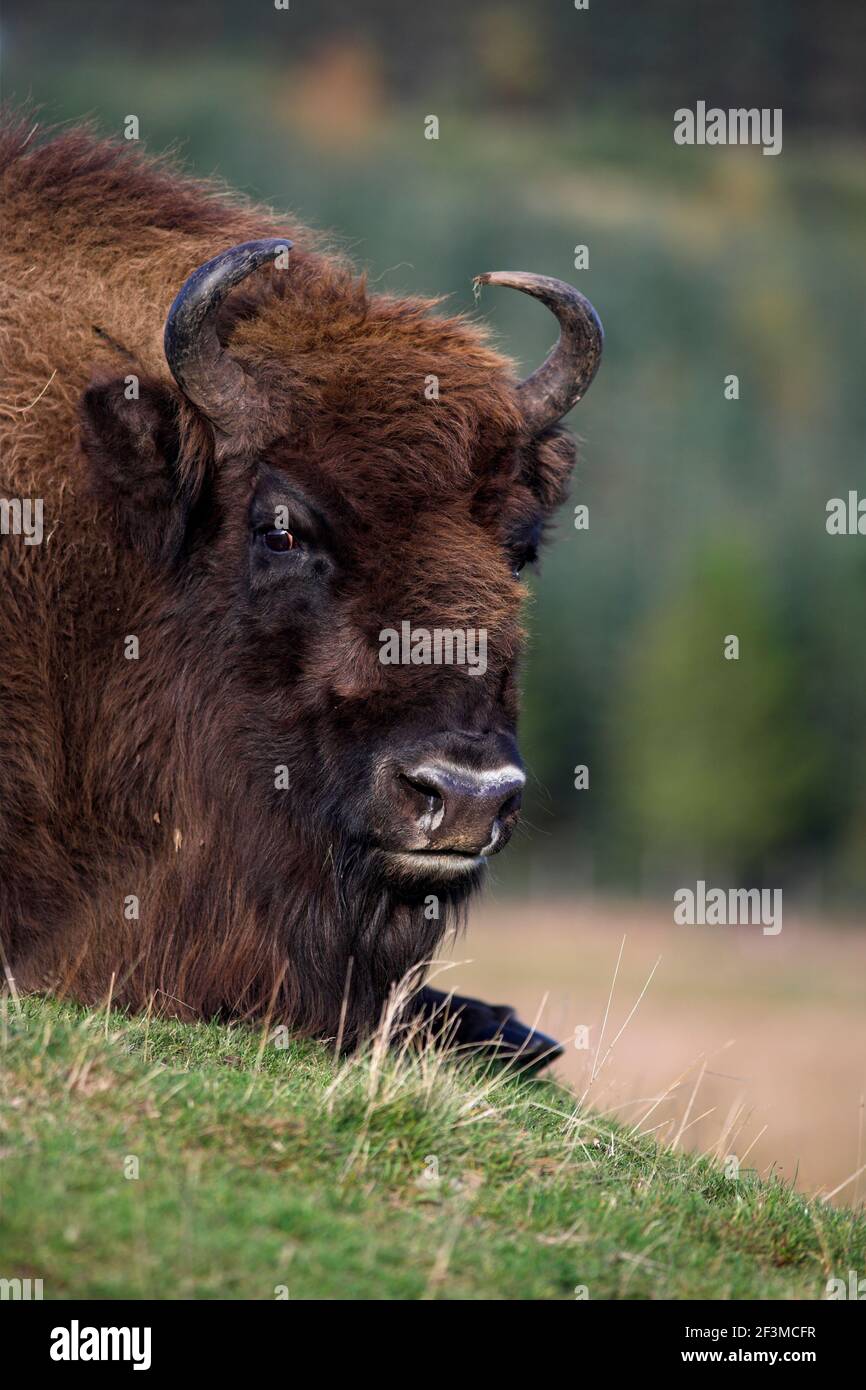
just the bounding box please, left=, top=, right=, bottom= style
left=79, top=375, right=195, bottom=563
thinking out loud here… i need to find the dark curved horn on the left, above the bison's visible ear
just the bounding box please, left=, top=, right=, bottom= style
left=164, top=238, right=292, bottom=434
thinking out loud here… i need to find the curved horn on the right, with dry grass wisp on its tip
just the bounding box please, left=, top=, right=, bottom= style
left=474, top=270, right=605, bottom=435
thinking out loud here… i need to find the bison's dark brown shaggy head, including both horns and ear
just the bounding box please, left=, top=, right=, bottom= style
left=77, top=240, right=602, bottom=1000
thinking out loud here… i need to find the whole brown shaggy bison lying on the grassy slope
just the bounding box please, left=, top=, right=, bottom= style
left=0, top=118, right=602, bottom=1059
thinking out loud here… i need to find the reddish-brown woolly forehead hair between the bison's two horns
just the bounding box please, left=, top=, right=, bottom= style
left=218, top=250, right=521, bottom=488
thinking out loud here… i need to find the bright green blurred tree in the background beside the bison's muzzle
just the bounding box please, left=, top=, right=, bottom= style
left=620, top=541, right=822, bottom=880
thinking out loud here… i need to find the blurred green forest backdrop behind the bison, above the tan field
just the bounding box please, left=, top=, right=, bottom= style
left=6, top=0, right=866, bottom=913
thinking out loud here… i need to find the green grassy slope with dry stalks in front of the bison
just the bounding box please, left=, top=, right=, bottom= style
left=0, top=998, right=866, bottom=1298
